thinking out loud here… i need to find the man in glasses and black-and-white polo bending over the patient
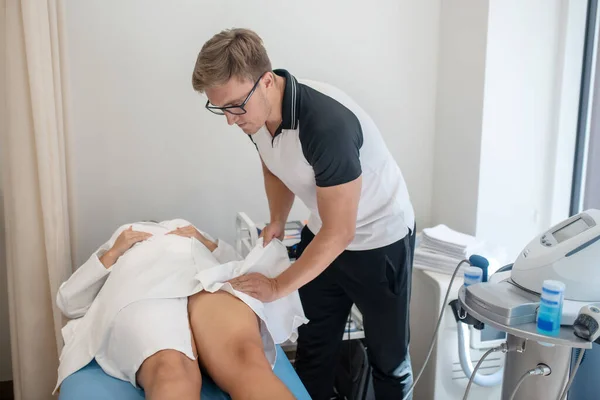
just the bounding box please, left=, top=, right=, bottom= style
left=192, top=29, right=415, bottom=400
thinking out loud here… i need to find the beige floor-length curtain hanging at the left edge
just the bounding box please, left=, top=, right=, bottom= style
left=0, top=0, right=72, bottom=400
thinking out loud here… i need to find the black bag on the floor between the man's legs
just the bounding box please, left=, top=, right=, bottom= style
left=335, top=340, right=375, bottom=400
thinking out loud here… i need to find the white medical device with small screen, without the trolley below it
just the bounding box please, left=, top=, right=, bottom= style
left=465, top=210, right=600, bottom=326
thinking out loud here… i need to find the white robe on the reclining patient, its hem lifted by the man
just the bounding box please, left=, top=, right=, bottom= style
left=57, top=220, right=308, bottom=388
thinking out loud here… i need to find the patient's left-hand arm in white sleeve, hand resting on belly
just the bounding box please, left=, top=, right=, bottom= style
left=56, top=227, right=151, bottom=318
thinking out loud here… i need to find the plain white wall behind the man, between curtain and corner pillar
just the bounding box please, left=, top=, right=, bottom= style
left=66, top=0, right=440, bottom=263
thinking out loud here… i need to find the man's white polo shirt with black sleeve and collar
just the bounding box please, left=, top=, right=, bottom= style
left=250, top=70, right=415, bottom=250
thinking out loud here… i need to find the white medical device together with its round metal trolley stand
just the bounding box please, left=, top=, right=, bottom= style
left=459, top=210, right=600, bottom=400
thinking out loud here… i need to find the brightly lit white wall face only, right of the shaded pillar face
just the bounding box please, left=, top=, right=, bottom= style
left=477, top=0, right=564, bottom=256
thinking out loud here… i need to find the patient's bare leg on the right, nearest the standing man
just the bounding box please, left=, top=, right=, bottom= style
left=188, top=291, right=294, bottom=400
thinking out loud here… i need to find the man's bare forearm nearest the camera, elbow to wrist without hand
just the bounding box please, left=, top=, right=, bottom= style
left=276, top=230, right=354, bottom=297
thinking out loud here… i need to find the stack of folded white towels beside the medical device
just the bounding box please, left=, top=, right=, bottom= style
left=413, top=225, right=496, bottom=276
